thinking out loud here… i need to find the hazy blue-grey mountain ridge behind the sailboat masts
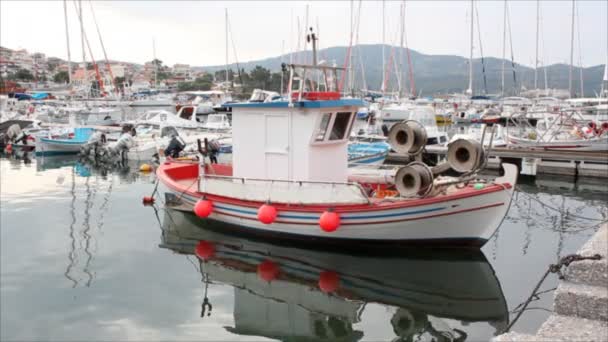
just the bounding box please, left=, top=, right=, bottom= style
left=195, top=44, right=604, bottom=96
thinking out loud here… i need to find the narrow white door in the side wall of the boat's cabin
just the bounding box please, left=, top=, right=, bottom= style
left=264, top=114, right=290, bottom=180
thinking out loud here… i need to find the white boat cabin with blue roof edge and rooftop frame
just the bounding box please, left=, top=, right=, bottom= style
left=230, top=60, right=364, bottom=182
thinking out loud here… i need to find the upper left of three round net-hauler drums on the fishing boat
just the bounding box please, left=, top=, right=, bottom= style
left=388, top=120, right=427, bottom=155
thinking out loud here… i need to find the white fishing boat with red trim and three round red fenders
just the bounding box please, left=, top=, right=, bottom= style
left=157, top=31, right=517, bottom=246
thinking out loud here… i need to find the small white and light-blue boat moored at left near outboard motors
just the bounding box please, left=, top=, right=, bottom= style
left=36, top=127, right=94, bottom=155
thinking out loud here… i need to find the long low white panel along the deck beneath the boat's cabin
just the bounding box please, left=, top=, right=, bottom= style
left=198, top=173, right=370, bottom=205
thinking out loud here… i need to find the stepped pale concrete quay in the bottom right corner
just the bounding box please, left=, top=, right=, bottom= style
left=493, top=224, right=608, bottom=342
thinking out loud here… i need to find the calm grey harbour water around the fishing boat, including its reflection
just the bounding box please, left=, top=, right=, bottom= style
left=0, top=157, right=608, bottom=341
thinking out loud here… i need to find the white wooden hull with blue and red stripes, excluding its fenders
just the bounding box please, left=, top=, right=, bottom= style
left=159, top=164, right=517, bottom=246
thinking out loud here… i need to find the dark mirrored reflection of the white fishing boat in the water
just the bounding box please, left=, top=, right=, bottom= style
left=160, top=209, right=508, bottom=341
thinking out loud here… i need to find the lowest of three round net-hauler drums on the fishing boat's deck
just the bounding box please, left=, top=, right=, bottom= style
left=395, top=162, right=433, bottom=197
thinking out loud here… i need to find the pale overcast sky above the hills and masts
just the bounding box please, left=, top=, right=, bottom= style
left=0, top=0, right=608, bottom=66
